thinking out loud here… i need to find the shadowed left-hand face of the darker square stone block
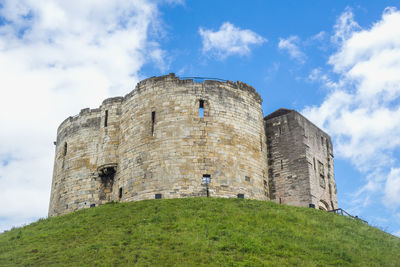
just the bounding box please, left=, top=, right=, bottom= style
left=265, top=113, right=311, bottom=206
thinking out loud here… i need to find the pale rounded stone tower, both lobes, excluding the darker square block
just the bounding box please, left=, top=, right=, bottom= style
left=49, top=74, right=269, bottom=216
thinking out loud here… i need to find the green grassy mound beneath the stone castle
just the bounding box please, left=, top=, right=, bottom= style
left=0, top=198, right=400, bottom=266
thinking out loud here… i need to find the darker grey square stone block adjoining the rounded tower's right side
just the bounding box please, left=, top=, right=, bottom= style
left=265, top=110, right=337, bottom=210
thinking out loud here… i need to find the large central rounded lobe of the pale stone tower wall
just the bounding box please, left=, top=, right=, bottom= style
left=115, top=76, right=266, bottom=204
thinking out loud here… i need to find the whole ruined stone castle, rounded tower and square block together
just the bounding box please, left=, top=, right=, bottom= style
left=49, top=74, right=337, bottom=216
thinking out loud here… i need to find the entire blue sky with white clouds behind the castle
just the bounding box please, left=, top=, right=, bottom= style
left=0, top=0, right=400, bottom=236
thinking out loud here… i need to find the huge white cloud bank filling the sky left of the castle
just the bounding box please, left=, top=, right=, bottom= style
left=0, top=0, right=169, bottom=231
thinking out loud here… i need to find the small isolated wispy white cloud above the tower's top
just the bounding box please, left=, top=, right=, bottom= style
left=199, top=22, right=267, bottom=59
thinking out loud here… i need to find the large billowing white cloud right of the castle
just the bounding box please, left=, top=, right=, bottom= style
left=304, top=8, right=400, bottom=209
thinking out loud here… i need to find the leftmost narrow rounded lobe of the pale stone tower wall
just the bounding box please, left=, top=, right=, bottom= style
left=49, top=109, right=101, bottom=215
